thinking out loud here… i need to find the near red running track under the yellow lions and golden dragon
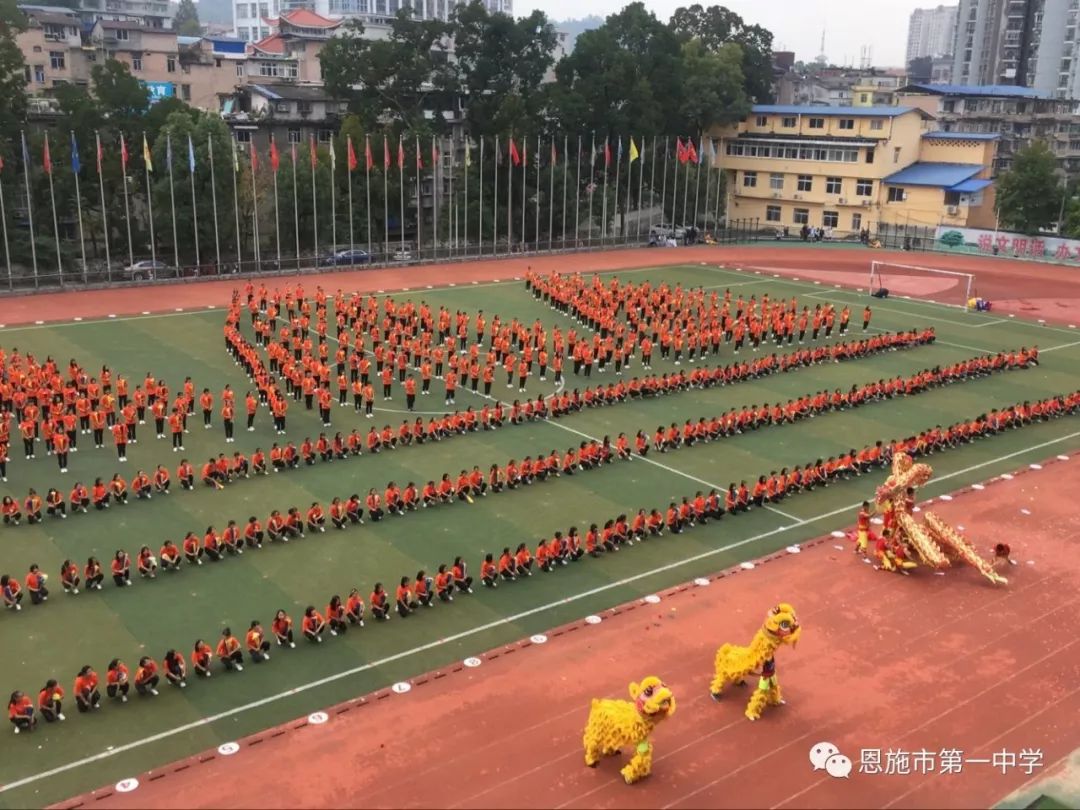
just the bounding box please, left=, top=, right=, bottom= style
left=58, top=457, right=1080, bottom=808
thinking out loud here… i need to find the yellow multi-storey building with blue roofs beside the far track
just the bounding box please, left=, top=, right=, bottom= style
left=711, top=105, right=997, bottom=235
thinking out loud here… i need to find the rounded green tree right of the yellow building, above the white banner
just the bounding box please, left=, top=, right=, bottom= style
left=997, top=140, right=1063, bottom=233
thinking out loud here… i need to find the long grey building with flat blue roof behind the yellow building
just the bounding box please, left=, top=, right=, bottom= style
left=896, top=84, right=1080, bottom=174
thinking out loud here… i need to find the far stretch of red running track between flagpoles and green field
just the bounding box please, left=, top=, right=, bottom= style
left=6, top=244, right=1080, bottom=326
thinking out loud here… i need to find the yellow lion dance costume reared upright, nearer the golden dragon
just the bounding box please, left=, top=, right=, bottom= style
left=708, top=602, right=802, bottom=720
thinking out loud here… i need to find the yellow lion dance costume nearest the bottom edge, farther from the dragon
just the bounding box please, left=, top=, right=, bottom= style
left=584, top=675, right=675, bottom=785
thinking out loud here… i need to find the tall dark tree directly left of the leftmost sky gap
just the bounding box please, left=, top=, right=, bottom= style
left=454, top=0, right=557, bottom=136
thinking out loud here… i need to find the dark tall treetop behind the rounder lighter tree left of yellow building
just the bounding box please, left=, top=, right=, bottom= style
left=670, top=3, right=772, bottom=104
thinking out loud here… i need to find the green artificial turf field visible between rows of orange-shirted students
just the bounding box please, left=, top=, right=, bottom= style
left=0, top=267, right=1080, bottom=807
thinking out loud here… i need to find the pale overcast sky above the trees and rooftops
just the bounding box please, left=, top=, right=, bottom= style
left=524, top=0, right=939, bottom=67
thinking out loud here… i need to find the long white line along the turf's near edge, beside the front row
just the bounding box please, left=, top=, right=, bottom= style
left=0, top=431, right=1080, bottom=794
